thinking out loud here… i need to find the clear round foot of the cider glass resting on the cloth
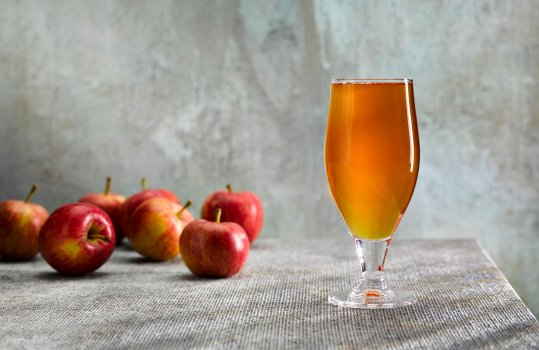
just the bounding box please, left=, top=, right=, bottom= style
left=328, top=290, right=417, bottom=309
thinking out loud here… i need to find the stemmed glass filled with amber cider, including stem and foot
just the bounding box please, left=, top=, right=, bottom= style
left=325, top=78, right=419, bottom=308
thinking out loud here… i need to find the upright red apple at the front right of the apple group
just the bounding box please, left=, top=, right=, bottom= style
left=180, top=209, right=249, bottom=277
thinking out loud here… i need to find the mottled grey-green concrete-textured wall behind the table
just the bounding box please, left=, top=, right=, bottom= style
left=0, top=0, right=539, bottom=315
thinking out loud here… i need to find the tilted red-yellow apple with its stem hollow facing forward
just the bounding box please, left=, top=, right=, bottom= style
left=39, top=203, right=116, bottom=276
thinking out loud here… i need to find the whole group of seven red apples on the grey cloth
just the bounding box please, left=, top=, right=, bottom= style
left=0, top=177, right=264, bottom=277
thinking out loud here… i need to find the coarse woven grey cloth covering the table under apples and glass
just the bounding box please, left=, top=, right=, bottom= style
left=0, top=239, right=539, bottom=349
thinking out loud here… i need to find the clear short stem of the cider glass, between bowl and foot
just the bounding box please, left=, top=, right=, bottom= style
left=355, top=238, right=391, bottom=296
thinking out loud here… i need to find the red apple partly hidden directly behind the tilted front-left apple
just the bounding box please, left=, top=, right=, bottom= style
left=79, top=176, right=125, bottom=245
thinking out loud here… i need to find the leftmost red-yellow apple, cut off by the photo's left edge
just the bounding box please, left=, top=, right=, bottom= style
left=0, top=184, right=49, bottom=260
